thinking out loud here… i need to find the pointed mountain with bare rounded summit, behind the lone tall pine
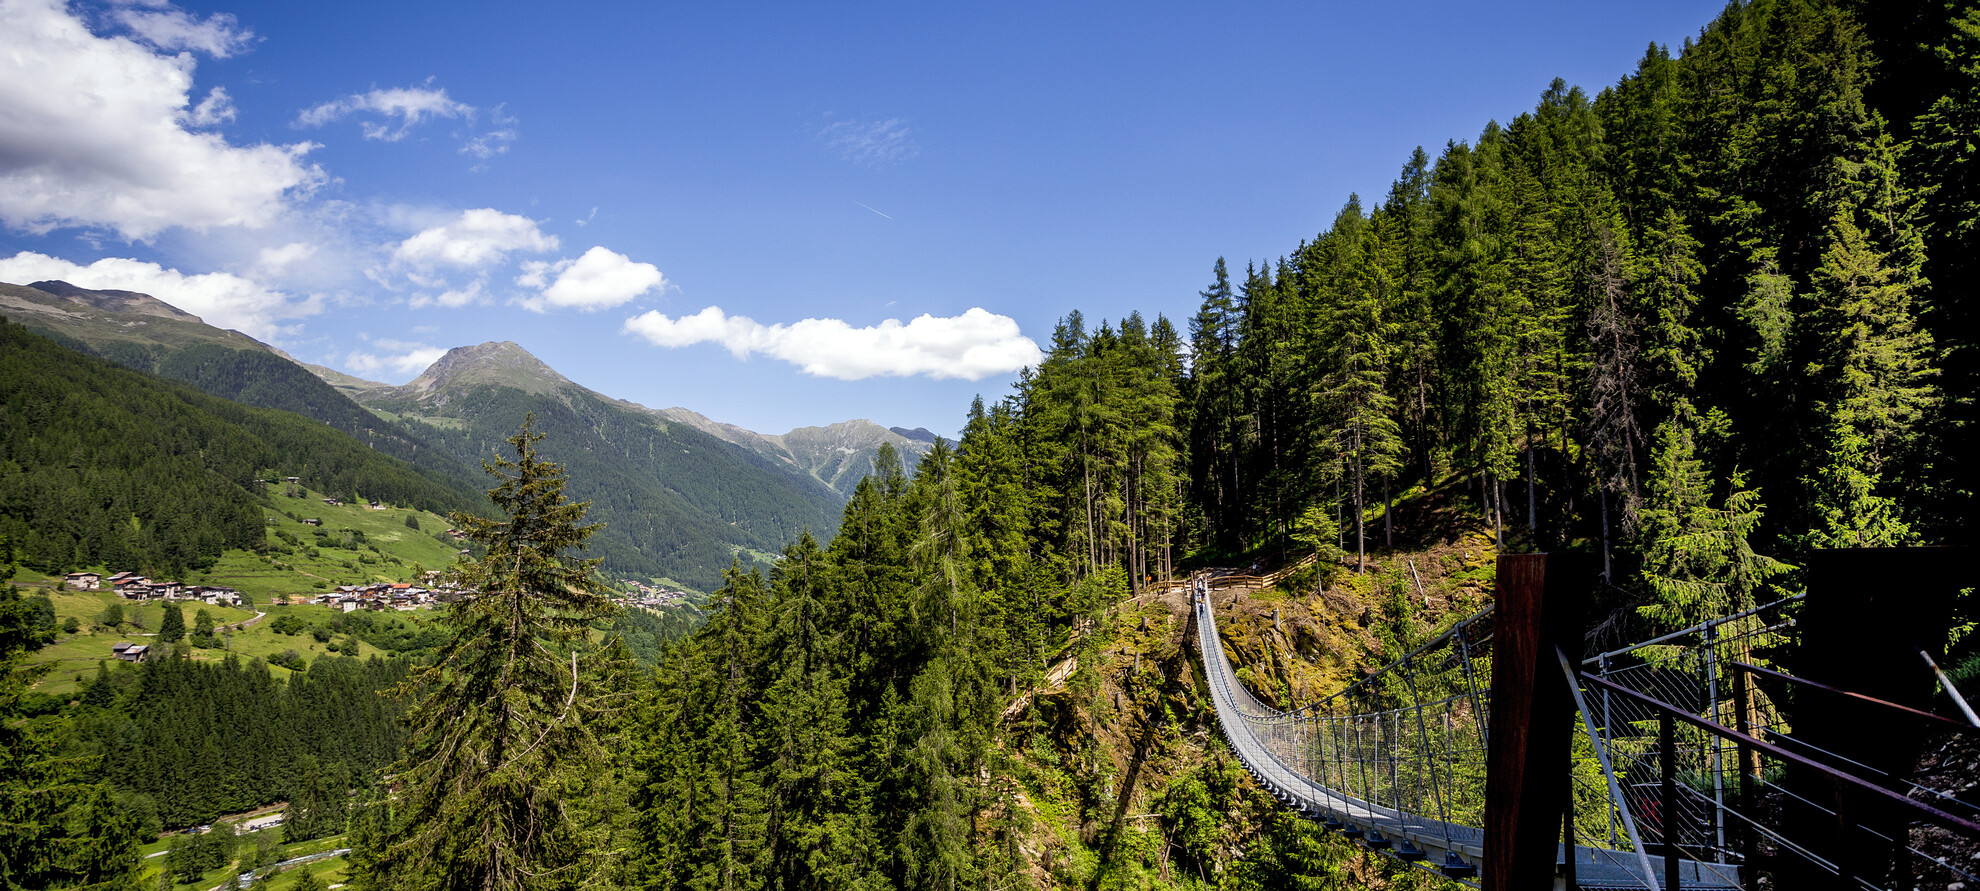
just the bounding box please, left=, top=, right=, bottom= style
left=360, top=343, right=840, bottom=588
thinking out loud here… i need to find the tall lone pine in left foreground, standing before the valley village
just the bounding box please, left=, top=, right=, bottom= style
left=362, top=418, right=612, bottom=891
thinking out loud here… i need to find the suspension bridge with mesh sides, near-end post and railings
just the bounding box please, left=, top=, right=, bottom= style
left=1190, top=548, right=1980, bottom=891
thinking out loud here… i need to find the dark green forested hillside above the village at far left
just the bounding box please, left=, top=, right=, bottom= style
left=0, top=323, right=473, bottom=576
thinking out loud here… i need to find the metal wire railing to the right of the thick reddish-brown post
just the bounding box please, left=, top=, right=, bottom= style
left=1574, top=596, right=1980, bottom=891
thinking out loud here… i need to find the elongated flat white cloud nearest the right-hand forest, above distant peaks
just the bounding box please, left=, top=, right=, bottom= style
left=624, top=307, right=1041, bottom=380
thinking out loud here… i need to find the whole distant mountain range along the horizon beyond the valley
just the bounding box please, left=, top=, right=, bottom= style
left=0, top=281, right=935, bottom=590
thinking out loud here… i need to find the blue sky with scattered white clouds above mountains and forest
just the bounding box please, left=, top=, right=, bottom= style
left=0, top=0, right=1723, bottom=434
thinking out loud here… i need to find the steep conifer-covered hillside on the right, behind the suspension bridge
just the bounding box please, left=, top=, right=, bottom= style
left=605, top=0, right=1980, bottom=887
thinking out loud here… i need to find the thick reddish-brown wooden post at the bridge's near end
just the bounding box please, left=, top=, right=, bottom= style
left=1483, top=554, right=1596, bottom=891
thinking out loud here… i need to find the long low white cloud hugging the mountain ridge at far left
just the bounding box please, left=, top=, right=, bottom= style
left=0, top=251, right=323, bottom=341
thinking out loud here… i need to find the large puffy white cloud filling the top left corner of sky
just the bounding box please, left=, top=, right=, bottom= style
left=0, top=0, right=325, bottom=240
